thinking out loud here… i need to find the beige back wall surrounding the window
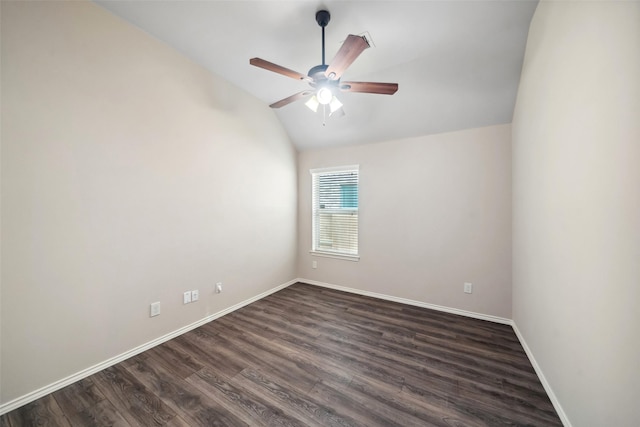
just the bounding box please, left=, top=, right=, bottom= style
left=298, top=125, right=511, bottom=318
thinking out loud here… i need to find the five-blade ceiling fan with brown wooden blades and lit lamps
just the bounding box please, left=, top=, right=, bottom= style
left=249, top=10, right=398, bottom=114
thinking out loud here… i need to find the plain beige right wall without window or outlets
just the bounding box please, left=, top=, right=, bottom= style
left=513, top=2, right=640, bottom=426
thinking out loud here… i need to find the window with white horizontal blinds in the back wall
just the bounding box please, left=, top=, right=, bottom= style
left=311, top=166, right=359, bottom=259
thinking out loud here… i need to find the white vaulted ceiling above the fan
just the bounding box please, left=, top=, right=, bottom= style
left=95, top=0, right=537, bottom=150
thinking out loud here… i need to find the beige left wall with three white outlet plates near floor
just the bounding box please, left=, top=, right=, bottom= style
left=1, top=1, right=296, bottom=403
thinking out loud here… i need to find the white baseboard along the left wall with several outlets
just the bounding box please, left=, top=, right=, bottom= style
left=0, top=279, right=298, bottom=415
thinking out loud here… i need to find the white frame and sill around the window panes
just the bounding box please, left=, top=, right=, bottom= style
left=309, top=165, right=360, bottom=261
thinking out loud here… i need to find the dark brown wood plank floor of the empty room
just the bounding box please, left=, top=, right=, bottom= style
left=0, top=284, right=562, bottom=427
